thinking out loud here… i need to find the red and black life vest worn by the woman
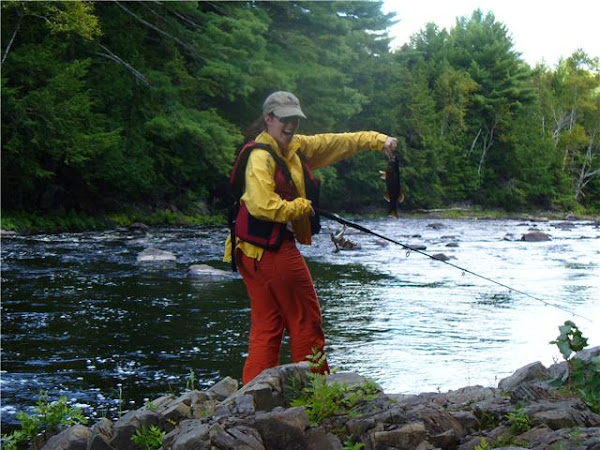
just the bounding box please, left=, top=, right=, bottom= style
left=229, top=141, right=320, bottom=270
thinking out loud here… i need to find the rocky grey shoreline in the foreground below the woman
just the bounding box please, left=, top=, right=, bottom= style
left=38, top=347, right=600, bottom=450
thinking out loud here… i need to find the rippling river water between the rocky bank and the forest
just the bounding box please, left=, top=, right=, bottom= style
left=1, top=218, right=600, bottom=427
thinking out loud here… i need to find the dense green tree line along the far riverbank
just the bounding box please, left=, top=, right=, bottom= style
left=1, top=1, right=600, bottom=214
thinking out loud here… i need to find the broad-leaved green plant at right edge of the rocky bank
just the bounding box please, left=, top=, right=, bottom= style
left=550, top=320, right=600, bottom=413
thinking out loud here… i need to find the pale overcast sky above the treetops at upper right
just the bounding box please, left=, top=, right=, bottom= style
left=383, top=0, right=600, bottom=67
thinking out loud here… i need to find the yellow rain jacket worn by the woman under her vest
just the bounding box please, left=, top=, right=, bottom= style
left=223, top=131, right=388, bottom=262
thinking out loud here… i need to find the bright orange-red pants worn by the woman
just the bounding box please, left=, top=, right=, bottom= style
left=237, top=239, right=329, bottom=384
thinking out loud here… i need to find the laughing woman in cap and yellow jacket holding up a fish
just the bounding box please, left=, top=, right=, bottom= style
left=224, top=91, right=397, bottom=384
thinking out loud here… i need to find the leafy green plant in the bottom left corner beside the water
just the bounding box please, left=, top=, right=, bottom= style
left=2, top=392, right=87, bottom=450
